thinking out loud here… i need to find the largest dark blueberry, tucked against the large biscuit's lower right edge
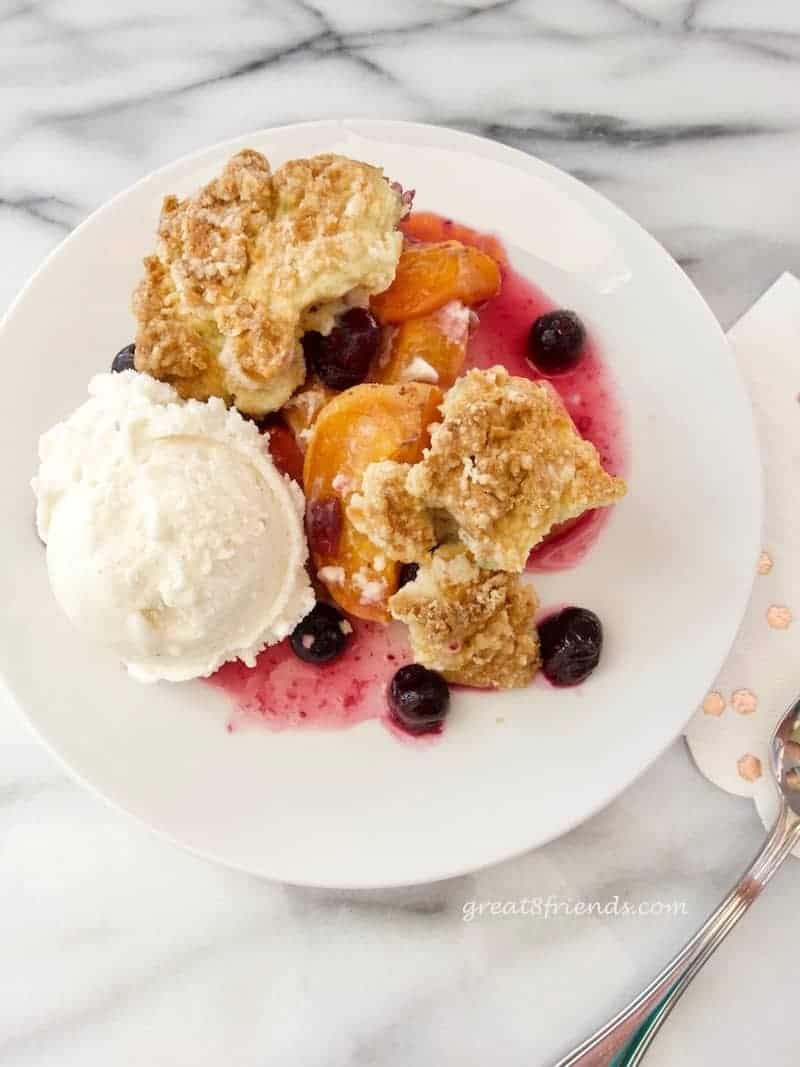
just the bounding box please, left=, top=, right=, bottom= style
left=303, top=307, right=381, bottom=389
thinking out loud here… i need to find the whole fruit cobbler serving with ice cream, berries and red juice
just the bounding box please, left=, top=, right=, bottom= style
left=34, top=149, right=625, bottom=735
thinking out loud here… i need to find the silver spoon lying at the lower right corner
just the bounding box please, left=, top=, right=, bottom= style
left=556, top=698, right=800, bottom=1067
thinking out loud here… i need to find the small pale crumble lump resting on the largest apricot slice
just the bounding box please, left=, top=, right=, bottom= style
left=347, top=460, right=437, bottom=563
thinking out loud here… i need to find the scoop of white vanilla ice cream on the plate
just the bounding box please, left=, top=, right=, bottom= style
left=32, top=370, right=314, bottom=682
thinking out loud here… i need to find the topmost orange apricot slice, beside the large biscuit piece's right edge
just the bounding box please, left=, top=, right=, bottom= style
left=371, top=241, right=500, bottom=323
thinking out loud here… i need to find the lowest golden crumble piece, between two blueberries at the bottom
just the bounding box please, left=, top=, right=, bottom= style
left=389, top=544, right=540, bottom=688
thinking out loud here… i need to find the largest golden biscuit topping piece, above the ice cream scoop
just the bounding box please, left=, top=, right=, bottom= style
left=133, top=148, right=405, bottom=415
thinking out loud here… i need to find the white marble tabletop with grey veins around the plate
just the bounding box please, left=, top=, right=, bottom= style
left=0, top=0, right=800, bottom=1067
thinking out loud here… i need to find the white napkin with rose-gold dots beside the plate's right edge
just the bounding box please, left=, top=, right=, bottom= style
left=686, top=274, right=800, bottom=856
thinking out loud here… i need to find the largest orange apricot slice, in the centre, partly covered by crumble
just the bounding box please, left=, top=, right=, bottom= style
left=303, top=382, right=442, bottom=622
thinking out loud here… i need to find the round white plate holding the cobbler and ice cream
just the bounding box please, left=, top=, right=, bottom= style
left=0, top=120, right=761, bottom=888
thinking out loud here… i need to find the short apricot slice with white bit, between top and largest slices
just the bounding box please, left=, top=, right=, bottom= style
left=370, top=301, right=470, bottom=389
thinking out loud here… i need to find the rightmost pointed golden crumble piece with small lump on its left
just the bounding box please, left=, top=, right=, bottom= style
left=351, top=367, right=625, bottom=571
